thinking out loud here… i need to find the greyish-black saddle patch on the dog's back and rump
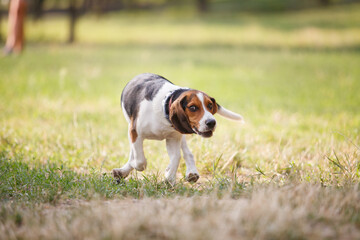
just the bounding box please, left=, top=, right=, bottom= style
left=121, top=73, right=172, bottom=119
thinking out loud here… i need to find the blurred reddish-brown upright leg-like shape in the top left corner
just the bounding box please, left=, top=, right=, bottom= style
left=3, top=0, right=26, bottom=55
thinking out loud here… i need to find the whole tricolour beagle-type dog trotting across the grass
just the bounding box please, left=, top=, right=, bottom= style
left=112, top=73, right=243, bottom=184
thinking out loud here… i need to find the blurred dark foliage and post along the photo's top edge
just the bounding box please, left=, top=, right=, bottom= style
left=0, top=0, right=359, bottom=43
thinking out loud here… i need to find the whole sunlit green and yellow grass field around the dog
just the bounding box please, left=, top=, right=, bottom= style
left=0, top=2, right=360, bottom=239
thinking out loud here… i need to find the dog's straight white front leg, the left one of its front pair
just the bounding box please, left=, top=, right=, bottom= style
left=165, top=138, right=181, bottom=184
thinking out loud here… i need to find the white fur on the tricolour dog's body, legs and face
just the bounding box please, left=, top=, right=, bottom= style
left=113, top=82, right=242, bottom=184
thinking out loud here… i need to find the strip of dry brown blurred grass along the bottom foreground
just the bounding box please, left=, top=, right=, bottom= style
left=0, top=184, right=360, bottom=240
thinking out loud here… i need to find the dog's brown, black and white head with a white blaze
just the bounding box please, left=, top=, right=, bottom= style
left=169, top=90, right=218, bottom=137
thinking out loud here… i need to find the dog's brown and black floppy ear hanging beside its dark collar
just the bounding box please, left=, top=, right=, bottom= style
left=169, top=95, right=194, bottom=134
